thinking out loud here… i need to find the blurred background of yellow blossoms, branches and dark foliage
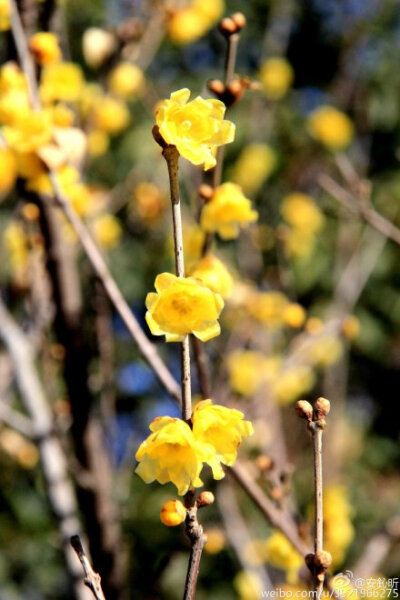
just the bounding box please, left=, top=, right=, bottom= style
left=0, top=0, right=400, bottom=600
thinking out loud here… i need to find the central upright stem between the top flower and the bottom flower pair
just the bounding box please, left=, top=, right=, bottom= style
left=163, top=146, right=192, bottom=422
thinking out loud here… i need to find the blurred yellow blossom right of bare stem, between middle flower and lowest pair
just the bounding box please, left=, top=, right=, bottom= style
left=228, top=350, right=280, bottom=396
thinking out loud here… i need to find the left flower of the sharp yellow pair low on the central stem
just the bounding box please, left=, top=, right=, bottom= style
left=136, top=417, right=208, bottom=496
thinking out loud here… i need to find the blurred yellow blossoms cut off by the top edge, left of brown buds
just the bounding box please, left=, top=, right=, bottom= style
left=167, top=0, right=225, bottom=45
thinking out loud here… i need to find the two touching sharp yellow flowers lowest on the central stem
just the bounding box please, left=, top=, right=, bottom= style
left=136, top=400, right=253, bottom=495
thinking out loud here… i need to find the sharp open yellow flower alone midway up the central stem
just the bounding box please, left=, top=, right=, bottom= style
left=146, top=273, right=224, bottom=342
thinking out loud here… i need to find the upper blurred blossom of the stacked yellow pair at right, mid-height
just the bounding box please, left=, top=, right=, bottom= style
left=281, top=192, right=325, bottom=233
